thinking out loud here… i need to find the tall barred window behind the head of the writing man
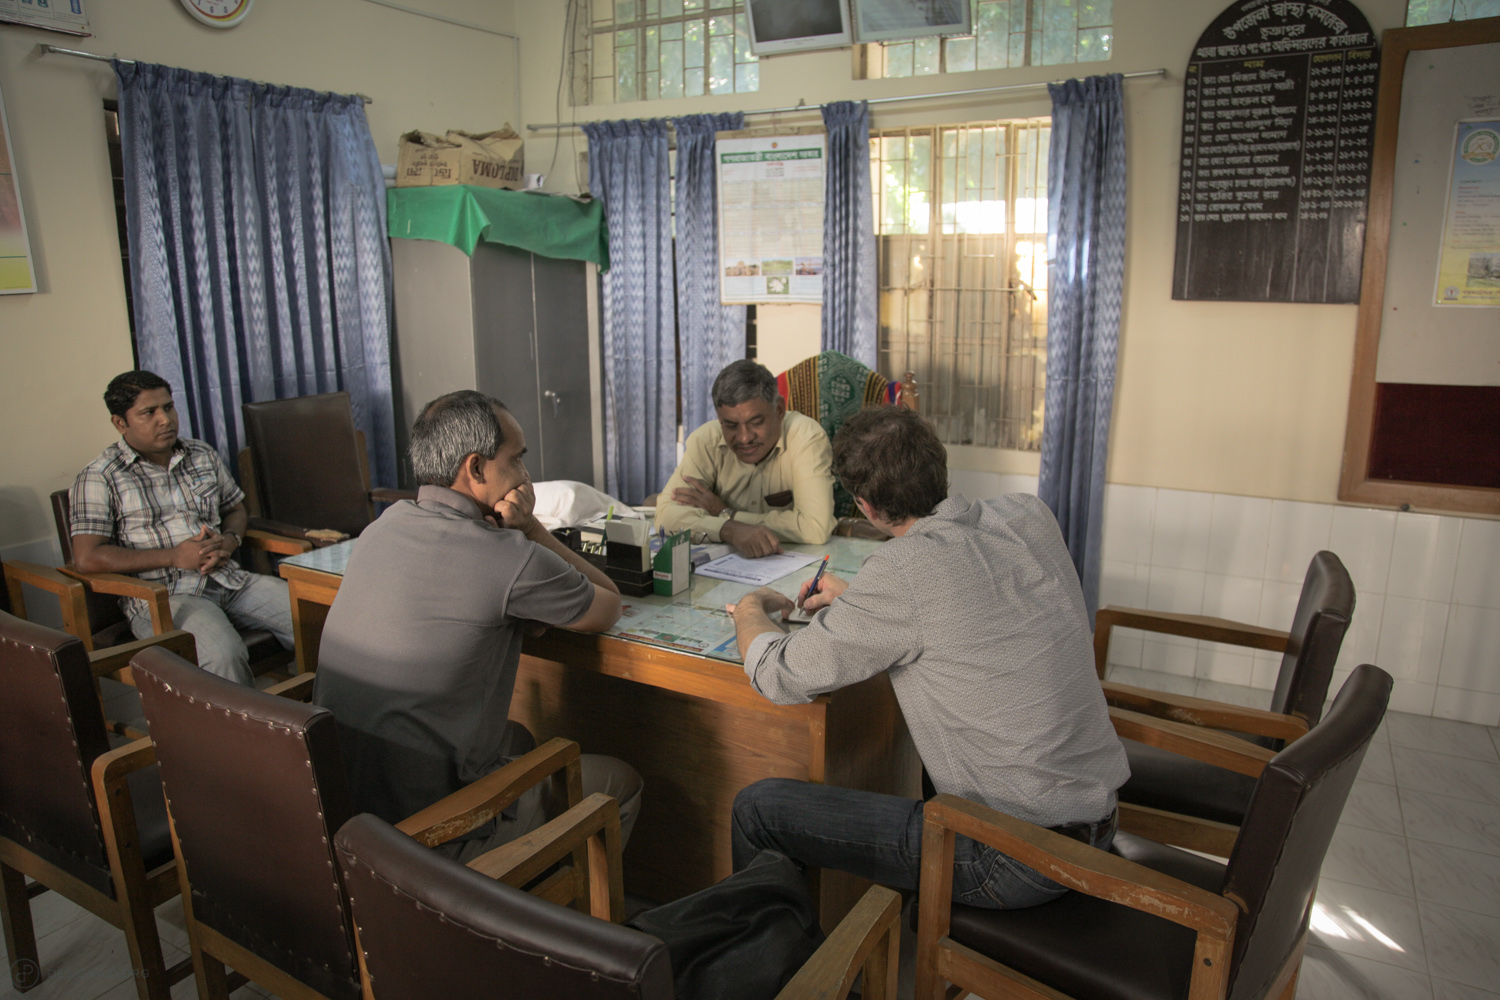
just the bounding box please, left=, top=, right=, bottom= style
left=870, top=118, right=1052, bottom=451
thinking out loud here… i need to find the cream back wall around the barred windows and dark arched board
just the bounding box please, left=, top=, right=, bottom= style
left=519, top=0, right=1406, bottom=502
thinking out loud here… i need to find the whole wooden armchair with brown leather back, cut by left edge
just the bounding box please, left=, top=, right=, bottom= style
left=0, top=614, right=192, bottom=1000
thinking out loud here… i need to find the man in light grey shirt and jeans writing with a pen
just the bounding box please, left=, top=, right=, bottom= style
left=731, top=406, right=1130, bottom=909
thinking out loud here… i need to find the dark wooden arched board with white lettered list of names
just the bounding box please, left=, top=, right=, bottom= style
left=1172, top=0, right=1379, bottom=303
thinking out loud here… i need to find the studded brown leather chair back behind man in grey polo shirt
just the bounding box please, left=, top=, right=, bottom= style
left=131, top=649, right=360, bottom=1000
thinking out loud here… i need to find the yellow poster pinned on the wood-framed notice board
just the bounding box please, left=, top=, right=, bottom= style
left=1437, top=118, right=1500, bottom=306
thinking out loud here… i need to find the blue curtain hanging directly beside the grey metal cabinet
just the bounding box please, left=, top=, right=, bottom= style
left=584, top=118, right=677, bottom=504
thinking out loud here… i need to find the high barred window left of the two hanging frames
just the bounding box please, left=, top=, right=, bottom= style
left=573, top=0, right=761, bottom=105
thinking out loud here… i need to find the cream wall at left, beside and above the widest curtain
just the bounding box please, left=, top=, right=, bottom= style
left=0, top=0, right=518, bottom=547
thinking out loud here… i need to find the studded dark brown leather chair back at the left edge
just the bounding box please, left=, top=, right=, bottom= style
left=0, top=612, right=114, bottom=897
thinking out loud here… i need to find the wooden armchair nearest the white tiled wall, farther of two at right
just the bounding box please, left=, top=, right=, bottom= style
left=1094, top=552, right=1355, bottom=858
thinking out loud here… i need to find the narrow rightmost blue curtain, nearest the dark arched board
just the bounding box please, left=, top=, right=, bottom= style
left=1038, top=73, right=1125, bottom=621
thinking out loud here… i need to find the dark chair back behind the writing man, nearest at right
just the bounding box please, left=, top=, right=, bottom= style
left=1224, top=664, right=1392, bottom=1000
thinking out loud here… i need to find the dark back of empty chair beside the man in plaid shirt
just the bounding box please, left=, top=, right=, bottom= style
left=240, top=393, right=375, bottom=535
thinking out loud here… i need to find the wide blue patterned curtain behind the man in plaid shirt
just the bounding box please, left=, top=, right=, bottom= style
left=114, top=61, right=396, bottom=486
